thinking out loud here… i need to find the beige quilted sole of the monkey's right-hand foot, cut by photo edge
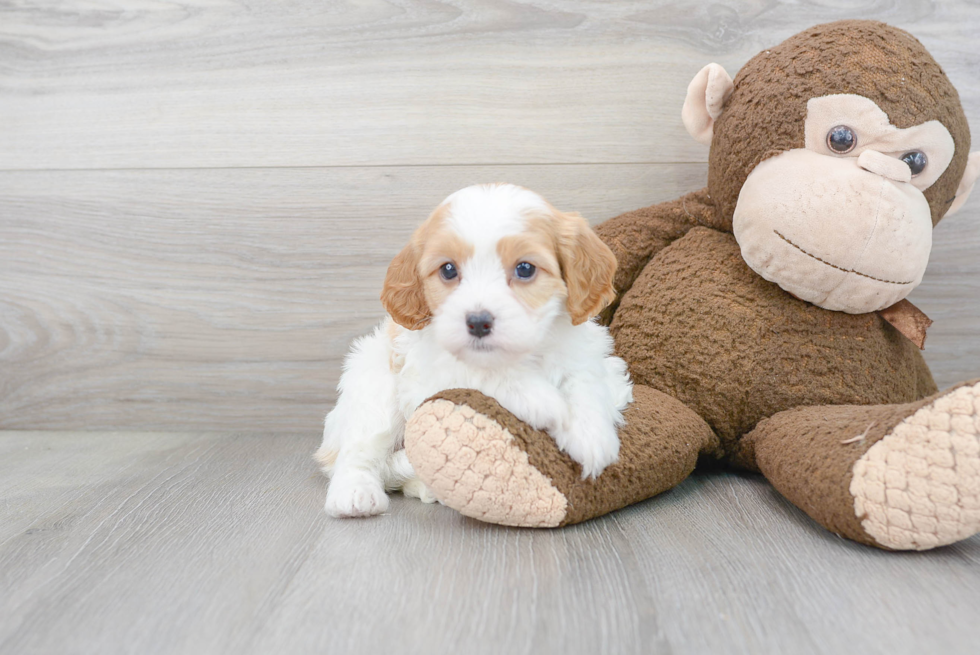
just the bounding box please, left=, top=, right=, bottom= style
left=850, top=383, right=980, bottom=550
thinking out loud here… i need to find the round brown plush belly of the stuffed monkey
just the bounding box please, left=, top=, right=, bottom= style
left=611, top=227, right=936, bottom=452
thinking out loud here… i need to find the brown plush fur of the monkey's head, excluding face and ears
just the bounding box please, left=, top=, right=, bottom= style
left=708, top=20, right=970, bottom=229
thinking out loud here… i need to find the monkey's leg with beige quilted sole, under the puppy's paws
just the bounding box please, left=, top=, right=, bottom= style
left=405, top=386, right=717, bottom=527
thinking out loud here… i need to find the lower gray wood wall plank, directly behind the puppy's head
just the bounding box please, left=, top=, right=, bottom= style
left=0, top=164, right=980, bottom=431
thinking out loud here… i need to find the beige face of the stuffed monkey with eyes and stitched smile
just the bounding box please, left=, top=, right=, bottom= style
left=720, top=93, right=972, bottom=314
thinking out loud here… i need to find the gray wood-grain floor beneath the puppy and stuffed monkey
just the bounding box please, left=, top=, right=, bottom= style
left=0, top=432, right=980, bottom=655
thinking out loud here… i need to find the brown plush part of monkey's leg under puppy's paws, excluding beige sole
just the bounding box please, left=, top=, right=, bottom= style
left=429, top=386, right=717, bottom=525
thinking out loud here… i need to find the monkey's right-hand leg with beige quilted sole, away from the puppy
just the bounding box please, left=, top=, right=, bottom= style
left=746, top=380, right=980, bottom=550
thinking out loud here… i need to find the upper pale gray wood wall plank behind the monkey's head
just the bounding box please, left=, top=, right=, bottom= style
left=0, top=0, right=980, bottom=169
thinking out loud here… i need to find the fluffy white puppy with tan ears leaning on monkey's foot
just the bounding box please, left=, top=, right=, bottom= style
left=315, top=184, right=633, bottom=517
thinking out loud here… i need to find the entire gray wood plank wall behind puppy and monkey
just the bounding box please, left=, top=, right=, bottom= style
left=0, top=0, right=980, bottom=431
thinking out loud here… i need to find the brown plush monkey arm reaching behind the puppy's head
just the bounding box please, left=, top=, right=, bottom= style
left=595, top=189, right=718, bottom=325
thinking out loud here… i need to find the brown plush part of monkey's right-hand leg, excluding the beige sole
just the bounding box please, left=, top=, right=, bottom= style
left=745, top=381, right=976, bottom=548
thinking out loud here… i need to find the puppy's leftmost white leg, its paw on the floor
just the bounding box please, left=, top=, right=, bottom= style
left=314, top=325, right=400, bottom=517
